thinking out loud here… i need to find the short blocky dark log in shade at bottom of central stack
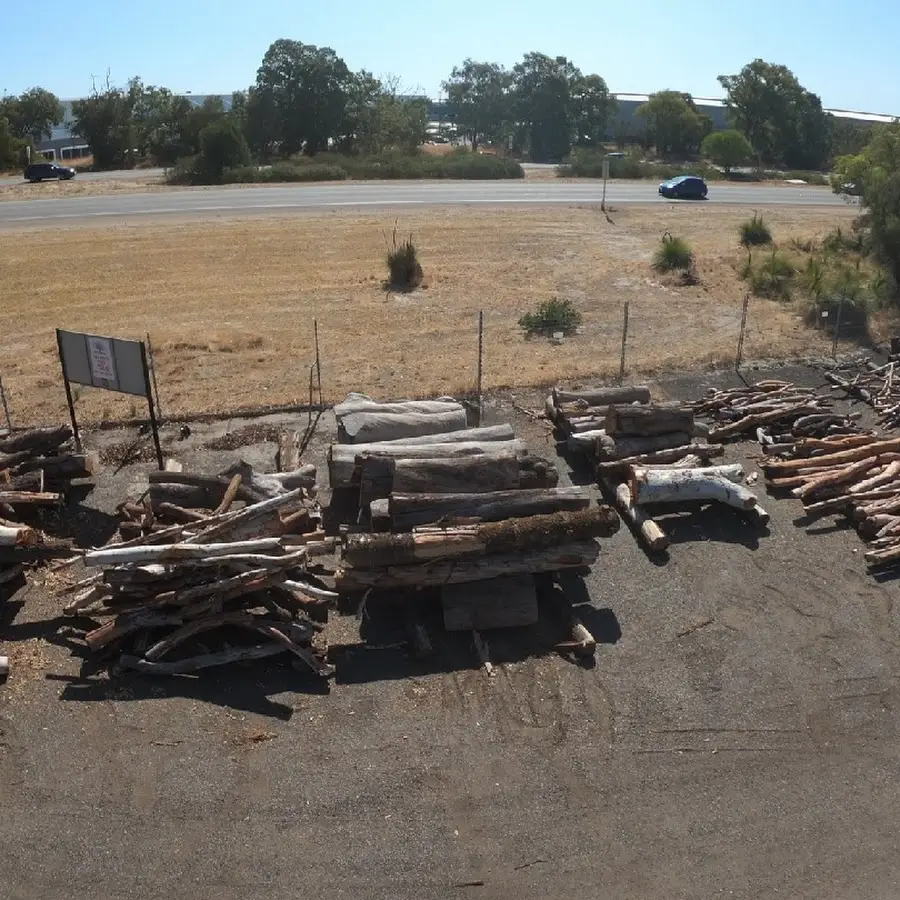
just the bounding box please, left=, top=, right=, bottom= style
left=441, top=575, right=538, bottom=631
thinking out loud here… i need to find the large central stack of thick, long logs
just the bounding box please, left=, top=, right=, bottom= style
left=329, top=395, right=618, bottom=649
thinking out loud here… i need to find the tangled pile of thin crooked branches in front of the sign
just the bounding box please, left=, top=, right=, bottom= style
left=64, top=492, right=337, bottom=676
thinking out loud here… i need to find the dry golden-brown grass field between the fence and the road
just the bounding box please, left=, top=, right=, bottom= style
left=0, top=205, right=853, bottom=423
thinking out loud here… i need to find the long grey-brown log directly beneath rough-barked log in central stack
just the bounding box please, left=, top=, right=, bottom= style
left=335, top=541, right=600, bottom=592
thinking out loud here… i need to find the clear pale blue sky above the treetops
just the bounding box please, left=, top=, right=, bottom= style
left=0, top=0, right=900, bottom=115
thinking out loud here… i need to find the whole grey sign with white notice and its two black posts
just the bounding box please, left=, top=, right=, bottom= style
left=56, top=328, right=165, bottom=469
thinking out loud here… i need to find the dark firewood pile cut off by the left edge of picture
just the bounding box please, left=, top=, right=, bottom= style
left=0, top=425, right=94, bottom=584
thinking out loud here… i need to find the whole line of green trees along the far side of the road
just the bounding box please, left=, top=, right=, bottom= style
left=0, top=46, right=884, bottom=169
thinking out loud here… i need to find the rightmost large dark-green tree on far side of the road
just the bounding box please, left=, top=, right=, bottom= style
left=719, top=59, right=830, bottom=169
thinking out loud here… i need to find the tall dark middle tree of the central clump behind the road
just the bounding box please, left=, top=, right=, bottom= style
left=513, top=53, right=582, bottom=162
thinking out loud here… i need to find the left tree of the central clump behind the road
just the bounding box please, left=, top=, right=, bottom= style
left=443, top=59, right=512, bottom=150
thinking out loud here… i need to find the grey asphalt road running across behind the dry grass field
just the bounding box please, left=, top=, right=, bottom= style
left=0, top=181, right=844, bottom=226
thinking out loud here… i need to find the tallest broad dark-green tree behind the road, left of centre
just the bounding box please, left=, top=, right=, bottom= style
left=256, top=39, right=352, bottom=156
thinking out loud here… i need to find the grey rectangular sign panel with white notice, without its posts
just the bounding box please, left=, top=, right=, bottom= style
left=56, top=331, right=149, bottom=397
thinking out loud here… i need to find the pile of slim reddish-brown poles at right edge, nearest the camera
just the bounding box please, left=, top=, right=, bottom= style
left=762, top=434, right=900, bottom=568
